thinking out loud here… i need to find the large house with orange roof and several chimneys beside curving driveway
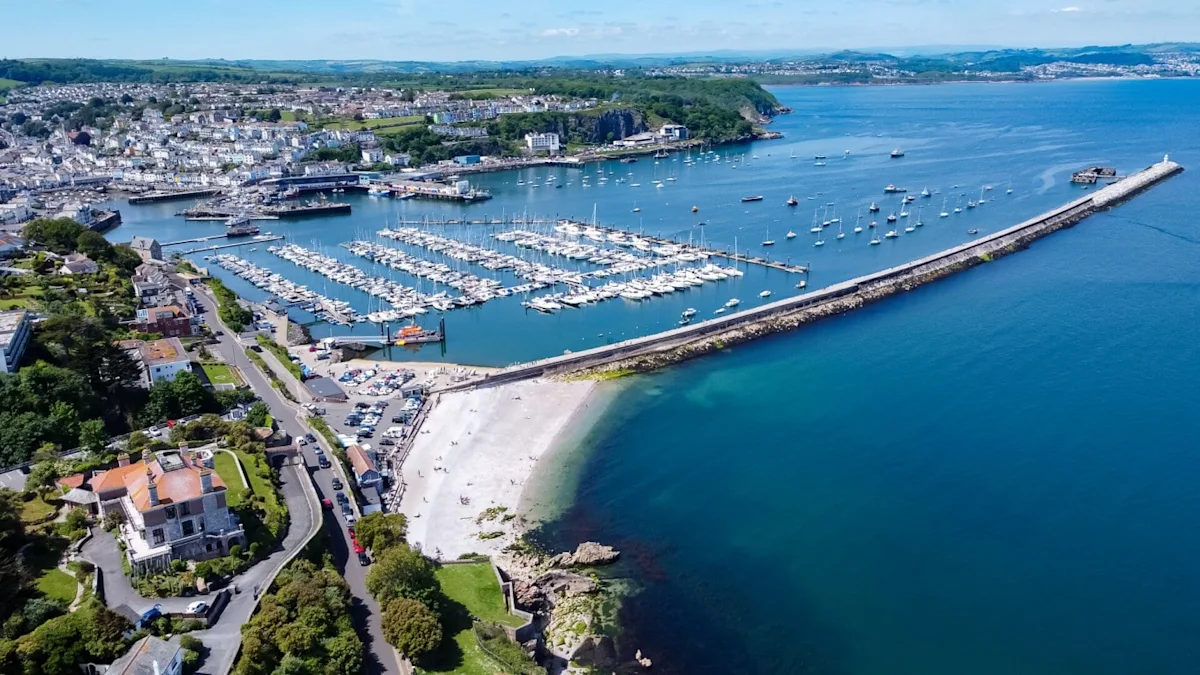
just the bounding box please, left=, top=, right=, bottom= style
left=91, top=443, right=246, bottom=574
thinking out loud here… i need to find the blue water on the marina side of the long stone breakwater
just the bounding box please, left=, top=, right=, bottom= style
left=108, top=82, right=1171, bottom=365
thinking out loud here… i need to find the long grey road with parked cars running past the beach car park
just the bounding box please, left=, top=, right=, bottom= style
left=188, top=288, right=406, bottom=675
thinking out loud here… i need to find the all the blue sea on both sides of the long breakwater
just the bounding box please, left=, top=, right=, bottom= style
left=108, top=80, right=1200, bottom=675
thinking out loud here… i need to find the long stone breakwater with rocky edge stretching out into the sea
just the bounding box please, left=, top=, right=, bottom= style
left=443, top=157, right=1183, bottom=390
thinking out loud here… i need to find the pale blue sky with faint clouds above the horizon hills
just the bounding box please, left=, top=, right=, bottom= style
left=9, top=0, right=1200, bottom=61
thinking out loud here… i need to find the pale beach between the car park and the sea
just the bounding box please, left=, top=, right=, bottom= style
left=400, top=380, right=596, bottom=560
